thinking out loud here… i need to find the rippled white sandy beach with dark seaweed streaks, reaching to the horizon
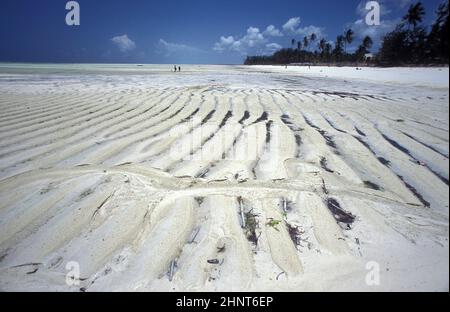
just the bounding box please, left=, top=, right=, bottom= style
left=0, top=64, right=449, bottom=291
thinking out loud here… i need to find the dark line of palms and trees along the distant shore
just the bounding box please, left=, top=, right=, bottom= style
left=245, top=0, right=449, bottom=66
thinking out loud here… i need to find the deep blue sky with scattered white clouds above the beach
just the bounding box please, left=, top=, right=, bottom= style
left=0, top=0, right=441, bottom=64
